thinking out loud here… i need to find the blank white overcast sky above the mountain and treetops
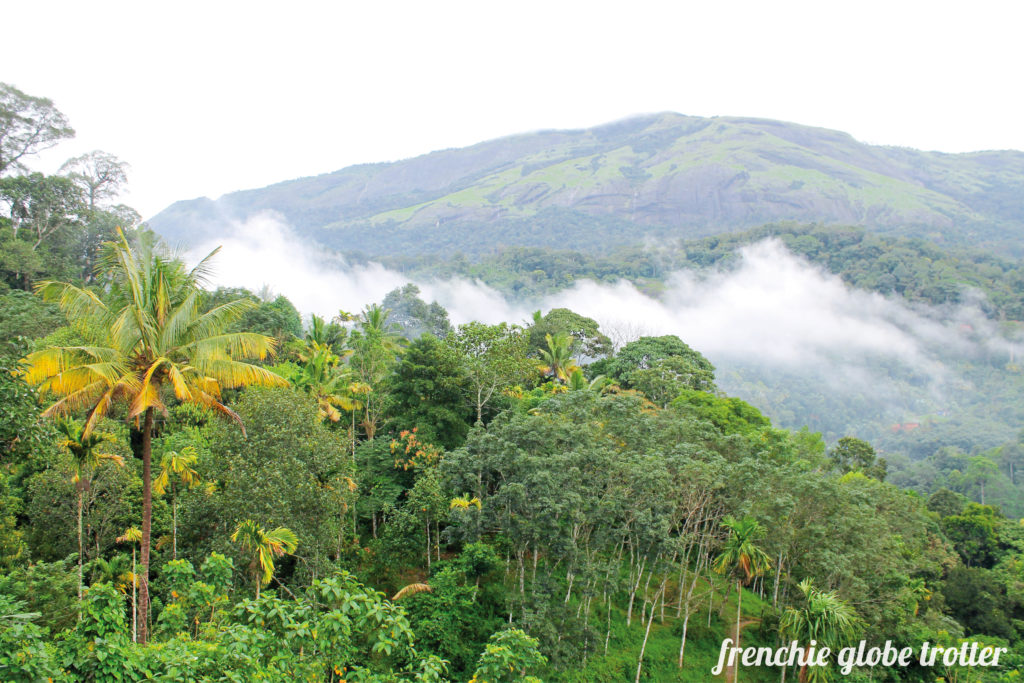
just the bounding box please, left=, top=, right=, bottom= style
left=8, top=0, right=1024, bottom=217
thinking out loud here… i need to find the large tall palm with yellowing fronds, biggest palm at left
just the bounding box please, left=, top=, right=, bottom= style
left=25, top=230, right=288, bottom=644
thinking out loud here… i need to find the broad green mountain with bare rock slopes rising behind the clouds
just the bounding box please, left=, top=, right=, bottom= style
left=151, top=114, right=1024, bottom=255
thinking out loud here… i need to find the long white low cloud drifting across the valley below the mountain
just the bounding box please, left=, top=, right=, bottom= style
left=189, top=214, right=1024, bottom=438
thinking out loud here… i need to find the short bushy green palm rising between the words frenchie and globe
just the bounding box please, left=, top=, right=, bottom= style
left=778, top=579, right=860, bottom=683
